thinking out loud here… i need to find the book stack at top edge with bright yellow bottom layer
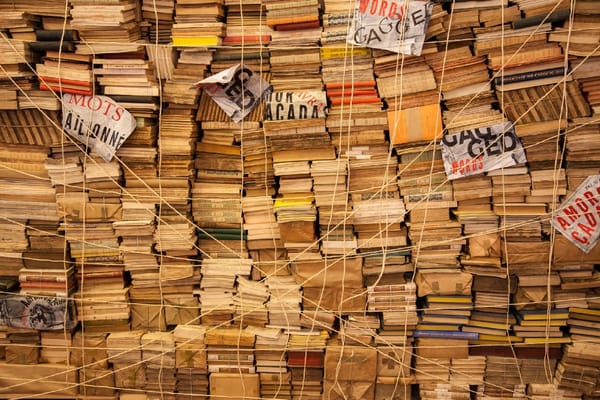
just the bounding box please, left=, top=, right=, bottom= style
left=172, top=0, right=225, bottom=47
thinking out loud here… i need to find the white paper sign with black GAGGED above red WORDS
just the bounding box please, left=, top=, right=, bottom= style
left=441, top=122, right=527, bottom=179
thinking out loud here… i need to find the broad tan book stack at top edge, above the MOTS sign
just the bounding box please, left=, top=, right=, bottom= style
left=71, top=0, right=141, bottom=54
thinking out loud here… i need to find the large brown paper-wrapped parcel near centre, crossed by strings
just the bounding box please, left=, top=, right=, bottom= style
left=292, top=257, right=363, bottom=288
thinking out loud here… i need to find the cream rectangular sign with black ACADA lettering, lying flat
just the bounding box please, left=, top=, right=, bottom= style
left=265, top=90, right=327, bottom=121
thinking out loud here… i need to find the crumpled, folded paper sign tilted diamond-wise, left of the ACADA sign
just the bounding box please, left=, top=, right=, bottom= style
left=194, top=64, right=271, bottom=122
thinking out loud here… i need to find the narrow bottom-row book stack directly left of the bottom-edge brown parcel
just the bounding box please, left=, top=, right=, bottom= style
left=173, top=324, right=208, bottom=397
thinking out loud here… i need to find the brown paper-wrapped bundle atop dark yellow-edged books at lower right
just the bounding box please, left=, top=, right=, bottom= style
left=415, top=270, right=473, bottom=297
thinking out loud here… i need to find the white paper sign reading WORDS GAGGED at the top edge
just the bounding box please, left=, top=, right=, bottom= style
left=346, top=0, right=433, bottom=56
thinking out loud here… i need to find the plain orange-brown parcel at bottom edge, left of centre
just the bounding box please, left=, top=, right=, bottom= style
left=210, top=372, right=260, bottom=400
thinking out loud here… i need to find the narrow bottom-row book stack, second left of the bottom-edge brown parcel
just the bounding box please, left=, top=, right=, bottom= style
left=140, top=332, right=177, bottom=393
